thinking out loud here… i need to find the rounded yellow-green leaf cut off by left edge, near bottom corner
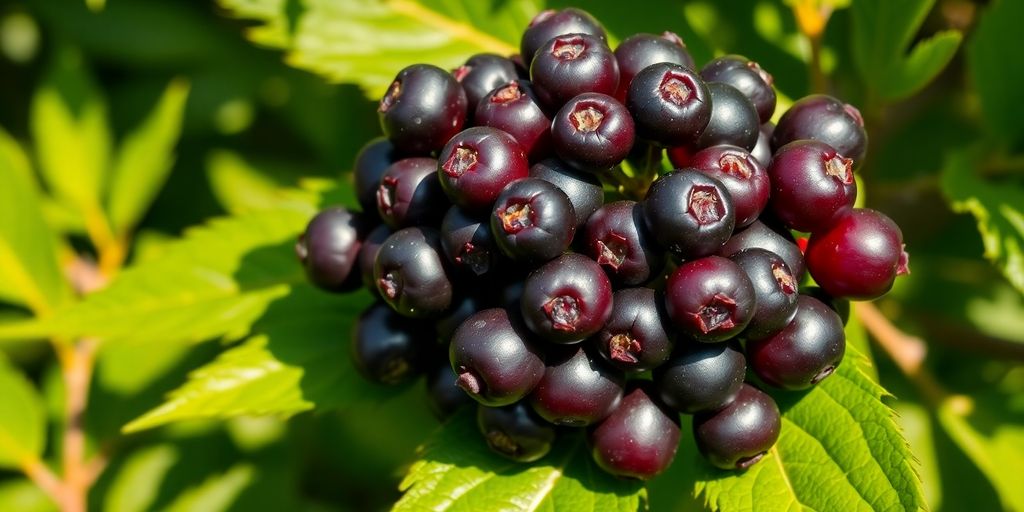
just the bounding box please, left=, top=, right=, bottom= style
left=0, top=358, right=46, bottom=469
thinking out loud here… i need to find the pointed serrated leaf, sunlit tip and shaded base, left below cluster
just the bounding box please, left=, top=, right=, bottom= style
left=124, top=286, right=386, bottom=432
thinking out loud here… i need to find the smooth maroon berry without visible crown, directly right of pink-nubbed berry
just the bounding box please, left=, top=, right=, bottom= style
left=529, top=345, right=626, bottom=427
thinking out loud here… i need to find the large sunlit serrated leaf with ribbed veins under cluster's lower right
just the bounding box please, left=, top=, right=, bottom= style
left=692, top=345, right=924, bottom=511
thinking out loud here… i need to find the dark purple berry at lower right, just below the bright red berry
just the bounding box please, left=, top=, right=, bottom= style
left=746, top=295, right=846, bottom=389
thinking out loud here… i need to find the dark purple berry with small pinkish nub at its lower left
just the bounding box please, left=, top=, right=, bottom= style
left=449, top=308, right=545, bottom=407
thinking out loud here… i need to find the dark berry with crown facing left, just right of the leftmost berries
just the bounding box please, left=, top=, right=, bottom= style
left=374, top=227, right=453, bottom=317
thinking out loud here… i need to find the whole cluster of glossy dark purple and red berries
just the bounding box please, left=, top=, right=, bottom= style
left=297, top=8, right=907, bottom=479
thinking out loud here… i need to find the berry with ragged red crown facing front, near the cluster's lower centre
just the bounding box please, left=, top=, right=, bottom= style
left=520, top=253, right=611, bottom=343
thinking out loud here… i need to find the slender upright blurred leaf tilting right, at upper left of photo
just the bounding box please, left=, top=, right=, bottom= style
left=108, top=80, right=188, bottom=232
